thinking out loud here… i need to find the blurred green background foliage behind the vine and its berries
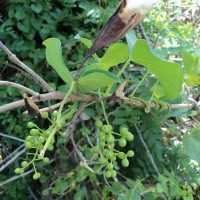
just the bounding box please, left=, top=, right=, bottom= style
left=0, top=0, right=200, bottom=200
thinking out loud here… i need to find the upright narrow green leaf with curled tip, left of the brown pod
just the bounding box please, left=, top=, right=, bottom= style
left=42, top=38, right=72, bottom=85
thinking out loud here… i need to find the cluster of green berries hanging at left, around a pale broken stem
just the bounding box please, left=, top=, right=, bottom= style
left=15, top=111, right=65, bottom=180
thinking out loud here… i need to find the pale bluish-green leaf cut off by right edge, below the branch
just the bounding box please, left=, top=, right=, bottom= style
left=183, top=125, right=200, bottom=162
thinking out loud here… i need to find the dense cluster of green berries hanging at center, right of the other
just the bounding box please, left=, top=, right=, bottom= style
left=92, top=121, right=134, bottom=178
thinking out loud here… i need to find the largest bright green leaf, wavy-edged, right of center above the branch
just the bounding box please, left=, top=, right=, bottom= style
left=131, top=40, right=183, bottom=100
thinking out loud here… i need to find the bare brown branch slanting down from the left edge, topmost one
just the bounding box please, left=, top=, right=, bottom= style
left=0, top=41, right=54, bottom=92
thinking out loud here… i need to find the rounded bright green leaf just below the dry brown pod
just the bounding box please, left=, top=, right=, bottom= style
left=101, top=43, right=128, bottom=70
